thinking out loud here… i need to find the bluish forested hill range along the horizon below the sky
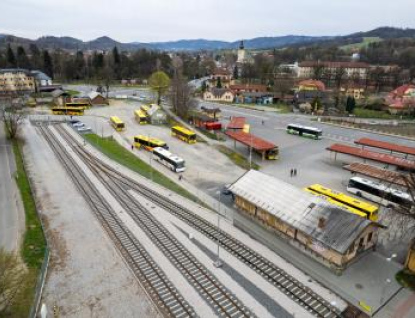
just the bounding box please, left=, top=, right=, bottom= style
left=0, top=27, right=415, bottom=51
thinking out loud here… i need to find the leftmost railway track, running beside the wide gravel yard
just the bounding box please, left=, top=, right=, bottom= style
left=39, top=126, right=197, bottom=317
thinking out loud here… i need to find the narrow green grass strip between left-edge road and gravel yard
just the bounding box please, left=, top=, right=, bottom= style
left=12, top=139, right=46, bottom=269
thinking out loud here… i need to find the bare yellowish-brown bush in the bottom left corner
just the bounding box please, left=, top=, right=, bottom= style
left=0, top=248, right=30, bottom=317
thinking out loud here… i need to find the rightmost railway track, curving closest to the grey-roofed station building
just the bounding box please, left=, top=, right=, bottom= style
left=53, top=124, right=342, bottom=318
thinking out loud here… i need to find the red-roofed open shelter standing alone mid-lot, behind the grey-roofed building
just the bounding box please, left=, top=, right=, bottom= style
left=225, top=130, right=278, bottom=160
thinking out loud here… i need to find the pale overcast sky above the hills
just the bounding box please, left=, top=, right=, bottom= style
left=0, top=0, right=415, bottom=42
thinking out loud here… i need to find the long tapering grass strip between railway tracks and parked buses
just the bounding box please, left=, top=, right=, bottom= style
left=84, top=134, right=202, bottom=204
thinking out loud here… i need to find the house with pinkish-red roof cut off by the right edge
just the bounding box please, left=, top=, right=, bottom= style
left=385, top=84, right=415, bottom=114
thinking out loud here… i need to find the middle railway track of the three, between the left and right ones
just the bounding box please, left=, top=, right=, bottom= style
left=50, top=128, right=255, bottom=318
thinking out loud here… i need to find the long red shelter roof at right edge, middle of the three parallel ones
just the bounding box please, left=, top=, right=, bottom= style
left=326, top=144, right=415, bottom=170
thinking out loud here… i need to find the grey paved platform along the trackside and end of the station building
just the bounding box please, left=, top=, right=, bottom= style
left=234, top=213, right=408, bottom=315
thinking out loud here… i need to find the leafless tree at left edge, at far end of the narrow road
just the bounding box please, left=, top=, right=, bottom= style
left=0, top=97, right=26, bottom=139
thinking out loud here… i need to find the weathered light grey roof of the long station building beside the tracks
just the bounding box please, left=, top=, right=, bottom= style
left=229, top=170, right=372, bottom=254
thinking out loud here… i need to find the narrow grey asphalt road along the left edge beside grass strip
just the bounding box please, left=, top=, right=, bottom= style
left=0, top=123, right=19, bottom=251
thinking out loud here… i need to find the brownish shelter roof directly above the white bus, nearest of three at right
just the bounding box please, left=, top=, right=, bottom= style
left=343, top=162, right=407, bottom=187
